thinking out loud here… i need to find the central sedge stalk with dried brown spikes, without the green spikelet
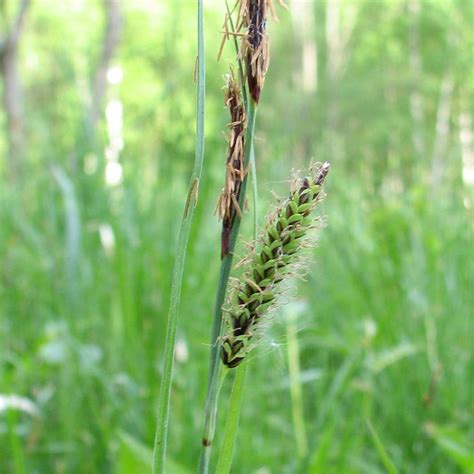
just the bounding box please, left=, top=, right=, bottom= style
left=199, top=0, right=273, bottom=473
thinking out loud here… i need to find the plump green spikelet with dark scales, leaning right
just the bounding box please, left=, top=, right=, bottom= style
left=221, top=162, right=329, bottom=368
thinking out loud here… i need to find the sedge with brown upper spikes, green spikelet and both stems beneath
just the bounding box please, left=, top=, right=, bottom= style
left=199, top=0, right=329, bottom=473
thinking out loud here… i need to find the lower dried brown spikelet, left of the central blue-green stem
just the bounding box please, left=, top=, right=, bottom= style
left=218, top=67, right=247, bottom=258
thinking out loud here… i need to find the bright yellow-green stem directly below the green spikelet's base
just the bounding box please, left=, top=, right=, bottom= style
left=216, top=361, right=247, bottom=474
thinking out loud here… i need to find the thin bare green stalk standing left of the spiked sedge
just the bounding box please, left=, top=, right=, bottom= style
left=152, top=0, right=206, bottom=474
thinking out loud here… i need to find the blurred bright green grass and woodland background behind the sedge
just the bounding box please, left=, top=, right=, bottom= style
left=0, top=0, right=474, bottom=474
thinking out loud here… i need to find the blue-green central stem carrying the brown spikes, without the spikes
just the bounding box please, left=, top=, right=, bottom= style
left=199, top=100, right=257, bottom=474
